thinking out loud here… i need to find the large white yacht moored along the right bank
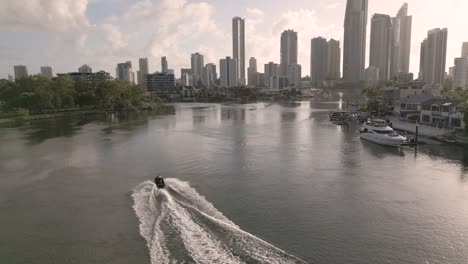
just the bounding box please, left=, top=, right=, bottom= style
left=360, top=119, right=406, bottom=147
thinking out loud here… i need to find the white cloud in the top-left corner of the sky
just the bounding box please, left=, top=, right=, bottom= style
left=0, top=0, right=88, bottom=32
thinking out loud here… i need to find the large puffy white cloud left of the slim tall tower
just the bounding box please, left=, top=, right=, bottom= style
left=107, top=0, right=228, bottom=73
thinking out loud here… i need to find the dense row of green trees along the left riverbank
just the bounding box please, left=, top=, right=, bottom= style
left=0, top=73, right=150, bottom=114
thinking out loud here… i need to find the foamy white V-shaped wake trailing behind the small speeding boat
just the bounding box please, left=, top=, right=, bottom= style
left=132, top=179, right=305, bottom=264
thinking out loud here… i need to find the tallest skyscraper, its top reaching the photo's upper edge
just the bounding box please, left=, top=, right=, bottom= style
left=343, top=0, right=367, bottom=82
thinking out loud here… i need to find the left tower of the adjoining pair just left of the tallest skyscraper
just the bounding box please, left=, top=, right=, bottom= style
left=310, top=37, right=328, bottom=85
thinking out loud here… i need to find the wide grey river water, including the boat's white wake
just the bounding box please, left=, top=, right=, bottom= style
left=0, top=100, right=468, bottom=264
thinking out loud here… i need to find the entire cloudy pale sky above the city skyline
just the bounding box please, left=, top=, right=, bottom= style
left=0, top=0, right=468, bottom=78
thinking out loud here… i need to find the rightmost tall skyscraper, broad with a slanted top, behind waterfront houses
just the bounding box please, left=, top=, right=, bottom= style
left=419, top=28, right=448, bottom=84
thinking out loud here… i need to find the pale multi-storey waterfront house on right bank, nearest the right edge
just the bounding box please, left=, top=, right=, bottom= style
left=420, top=99, right=465, bottom=129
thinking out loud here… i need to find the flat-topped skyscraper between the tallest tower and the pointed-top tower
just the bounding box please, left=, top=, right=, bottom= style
left=369, top=14, right=393, bottom=81
